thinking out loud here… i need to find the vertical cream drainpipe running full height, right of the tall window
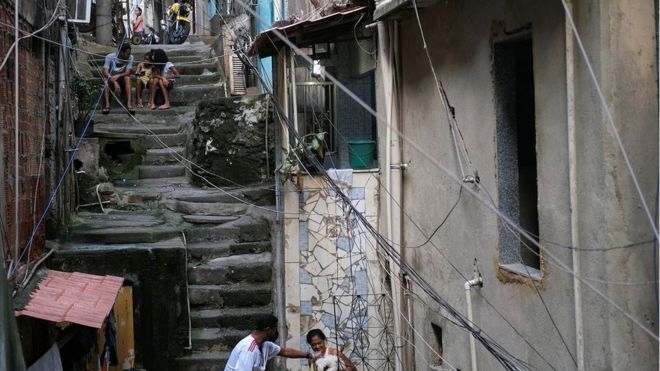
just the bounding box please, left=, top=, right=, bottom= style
left=565, top=0, right=584, bottom=371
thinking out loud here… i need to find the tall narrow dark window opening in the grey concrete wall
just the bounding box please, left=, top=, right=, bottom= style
left=493, top=33, right=540, bottom=278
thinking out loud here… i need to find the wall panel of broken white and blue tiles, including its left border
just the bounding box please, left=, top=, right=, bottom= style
left=285, top=172, right=392, bottom=370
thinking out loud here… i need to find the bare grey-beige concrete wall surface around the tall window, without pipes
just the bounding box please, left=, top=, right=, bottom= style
left=376, top=0, right=658, bottom=370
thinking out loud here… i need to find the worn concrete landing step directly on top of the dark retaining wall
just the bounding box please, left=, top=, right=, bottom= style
left=67, top=225, right=181, bottom=244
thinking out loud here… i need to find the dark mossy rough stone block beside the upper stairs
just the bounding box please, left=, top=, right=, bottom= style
left=187, top=95, right=275, bottom=185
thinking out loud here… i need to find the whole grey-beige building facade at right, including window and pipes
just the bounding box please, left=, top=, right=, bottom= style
left=374, top=0, right=658, bottom=370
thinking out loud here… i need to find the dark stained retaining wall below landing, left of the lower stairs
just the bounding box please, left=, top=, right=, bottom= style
left=48, top=248, right=188, bottom=370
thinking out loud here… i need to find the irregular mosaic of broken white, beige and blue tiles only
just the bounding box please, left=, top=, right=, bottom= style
left=292, top=176, right=394, bottom=371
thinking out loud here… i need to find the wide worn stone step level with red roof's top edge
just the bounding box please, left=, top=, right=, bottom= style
left=188, top=252, right=273, bottom=285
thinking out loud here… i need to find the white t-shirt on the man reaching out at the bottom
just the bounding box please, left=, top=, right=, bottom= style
left=225, top=335, right=281, bottom=371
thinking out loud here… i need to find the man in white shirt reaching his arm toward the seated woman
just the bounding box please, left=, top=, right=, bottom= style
left=225, top=314, right=314, bottom=371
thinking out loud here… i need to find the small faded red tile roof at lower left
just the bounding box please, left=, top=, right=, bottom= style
left=16, top=269, right=124, bottom=328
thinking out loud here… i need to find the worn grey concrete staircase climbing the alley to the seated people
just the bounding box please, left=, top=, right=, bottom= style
left=68, top=43, right=274, bottom=371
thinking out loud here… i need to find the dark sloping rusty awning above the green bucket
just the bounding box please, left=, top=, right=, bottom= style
left=248, top=6, right=367, bottom=57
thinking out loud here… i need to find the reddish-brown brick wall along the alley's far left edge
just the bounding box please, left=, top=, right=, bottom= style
left=0, top=1, right=58, bottom=266
